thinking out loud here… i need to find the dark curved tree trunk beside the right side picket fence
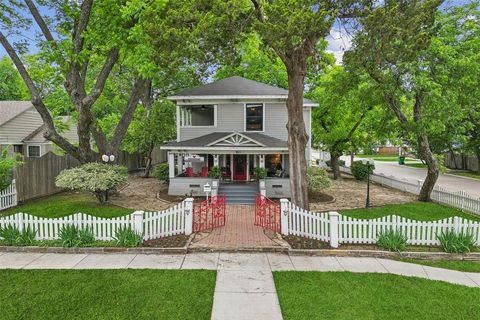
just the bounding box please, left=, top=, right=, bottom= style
left=417, top=132, right=440, bottom=202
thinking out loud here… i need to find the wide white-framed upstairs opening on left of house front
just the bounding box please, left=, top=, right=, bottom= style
left=180, top=105, right=217, bottom=127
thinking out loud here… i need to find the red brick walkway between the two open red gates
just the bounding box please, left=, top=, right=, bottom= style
left=190, top=205, right=278, bottom=248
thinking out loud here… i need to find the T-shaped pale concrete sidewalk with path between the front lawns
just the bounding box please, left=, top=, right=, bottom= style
left=0, top=253, right=480, bottom=319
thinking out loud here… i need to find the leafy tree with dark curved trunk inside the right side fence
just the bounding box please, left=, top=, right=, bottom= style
left=344, top=0, right=448, bottom=201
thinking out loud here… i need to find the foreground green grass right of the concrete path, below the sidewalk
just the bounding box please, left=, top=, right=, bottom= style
left=273, top=271, right=480, bottom=320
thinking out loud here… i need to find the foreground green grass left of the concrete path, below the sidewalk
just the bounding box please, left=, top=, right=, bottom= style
left=0, top=270, right=216, bottom=320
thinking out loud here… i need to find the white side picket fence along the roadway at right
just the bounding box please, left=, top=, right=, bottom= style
left=340, top=167, right=480, bottom=214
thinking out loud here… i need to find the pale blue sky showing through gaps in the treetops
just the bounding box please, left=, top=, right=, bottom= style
left=0, top=0, right=471, bottom=64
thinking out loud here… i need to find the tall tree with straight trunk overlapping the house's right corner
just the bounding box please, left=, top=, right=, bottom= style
left=252, top=0, right=370, bottom=208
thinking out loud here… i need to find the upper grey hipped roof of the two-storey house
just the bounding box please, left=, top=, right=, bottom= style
left=168, top=76, right=316, bottom=104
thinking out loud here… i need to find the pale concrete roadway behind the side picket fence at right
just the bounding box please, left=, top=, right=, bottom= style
left=342, top=157, right=480, bottom=197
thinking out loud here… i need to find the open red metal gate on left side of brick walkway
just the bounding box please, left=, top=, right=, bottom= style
left=193, top=194, right=226, bottom=232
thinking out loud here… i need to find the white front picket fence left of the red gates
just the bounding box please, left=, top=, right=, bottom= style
left=0, top=198, right=193, bottom=241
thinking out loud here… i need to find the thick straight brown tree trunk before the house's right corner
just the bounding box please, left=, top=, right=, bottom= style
left=287, top=65, right=309, bottom=209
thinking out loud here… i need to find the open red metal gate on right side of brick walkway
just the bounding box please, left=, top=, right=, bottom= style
left=255, top=193, right=280, bottom=232
